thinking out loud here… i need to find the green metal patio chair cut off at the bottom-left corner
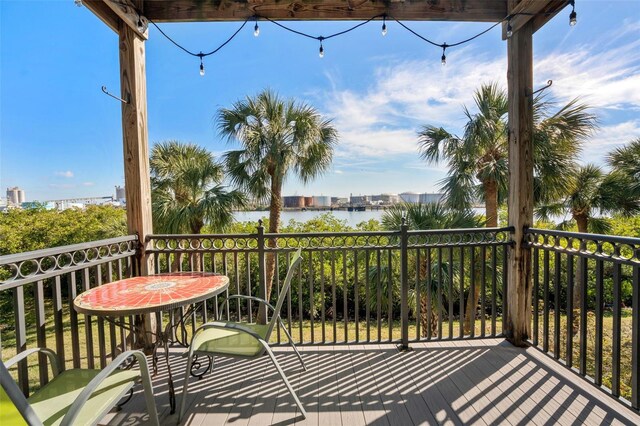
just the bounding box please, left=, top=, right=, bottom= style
left=0, top=348, right=160, bottom=426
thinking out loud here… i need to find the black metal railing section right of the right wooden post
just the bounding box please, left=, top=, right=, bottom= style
left=527, top=229, right=640, bottom=410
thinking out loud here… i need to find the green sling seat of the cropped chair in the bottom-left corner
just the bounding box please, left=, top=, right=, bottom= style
left=28, top=369, right=140, bottom=425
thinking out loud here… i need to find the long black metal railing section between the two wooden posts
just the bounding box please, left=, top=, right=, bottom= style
left=147, top=227, right=511, bottom=345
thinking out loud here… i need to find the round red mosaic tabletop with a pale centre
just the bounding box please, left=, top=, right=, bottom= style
left=73, top=272, right=229, bottom=317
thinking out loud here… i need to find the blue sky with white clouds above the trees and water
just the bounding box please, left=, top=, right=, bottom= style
left=0, top=0, right=640, bottom=200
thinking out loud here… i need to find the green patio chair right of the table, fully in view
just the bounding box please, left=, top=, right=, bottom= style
left=178, top=249, right=307, bottom=422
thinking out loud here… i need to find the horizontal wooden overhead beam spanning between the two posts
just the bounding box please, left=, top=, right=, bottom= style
left=144, top=0, right=507, bottom=22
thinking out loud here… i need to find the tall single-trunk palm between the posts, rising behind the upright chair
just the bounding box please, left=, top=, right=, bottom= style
left=216, top=90, right=338, bottom=310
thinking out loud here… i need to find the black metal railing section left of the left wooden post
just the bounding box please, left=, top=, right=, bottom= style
left=0, top=236, right=138, bottom=394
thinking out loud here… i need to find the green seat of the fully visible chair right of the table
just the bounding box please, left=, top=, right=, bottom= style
left=193, top=321, right=269, bottom=357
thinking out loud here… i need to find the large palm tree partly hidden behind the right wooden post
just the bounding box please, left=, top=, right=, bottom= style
left=418, top=83, right=595, bottom=332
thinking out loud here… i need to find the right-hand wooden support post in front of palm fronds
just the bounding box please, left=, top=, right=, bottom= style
left=505, top=21, right=533, bottom=346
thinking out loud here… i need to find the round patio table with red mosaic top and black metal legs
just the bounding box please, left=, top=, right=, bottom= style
left=73, top=272, right=229, bottom=414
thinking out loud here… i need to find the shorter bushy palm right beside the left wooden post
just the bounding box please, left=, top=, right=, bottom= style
left=149, top=141, right=244, bottom=270
